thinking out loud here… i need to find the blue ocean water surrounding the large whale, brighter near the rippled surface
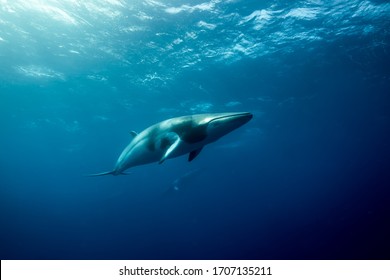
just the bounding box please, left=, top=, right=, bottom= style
left=0, top=0, right=390, bottom=259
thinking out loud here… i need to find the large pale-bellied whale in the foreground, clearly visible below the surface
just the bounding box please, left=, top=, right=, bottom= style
left=87, top=112, right=253, bottom=177
